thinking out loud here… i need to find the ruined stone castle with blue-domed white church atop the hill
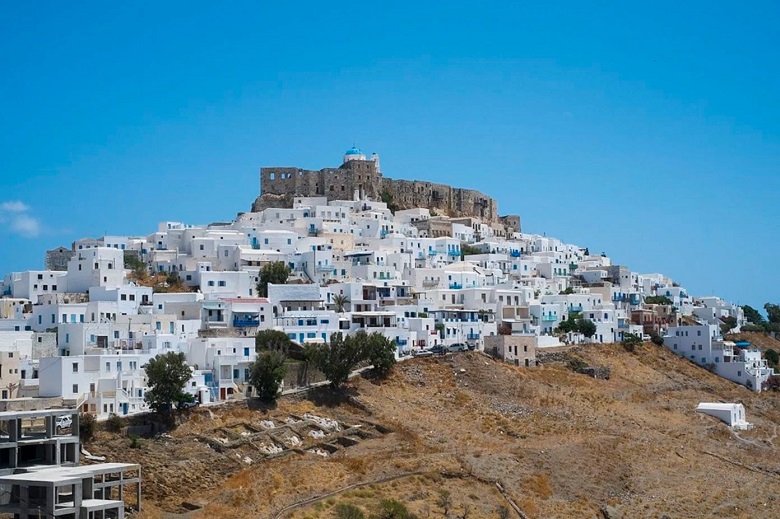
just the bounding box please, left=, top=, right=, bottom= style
left=252, top=147, right=520, bottom=231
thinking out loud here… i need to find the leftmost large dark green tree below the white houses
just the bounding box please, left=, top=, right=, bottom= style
left=142, top=352, right=192, bottom=414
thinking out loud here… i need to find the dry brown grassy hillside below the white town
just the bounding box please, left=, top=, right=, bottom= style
left=89, top=344, right=780, bottom=519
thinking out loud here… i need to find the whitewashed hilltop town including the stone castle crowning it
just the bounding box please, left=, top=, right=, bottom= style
left=0, top=148, right=773, bottom=419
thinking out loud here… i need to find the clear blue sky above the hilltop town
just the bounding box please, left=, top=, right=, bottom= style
left=0, top=1, right=780, bottom=307
